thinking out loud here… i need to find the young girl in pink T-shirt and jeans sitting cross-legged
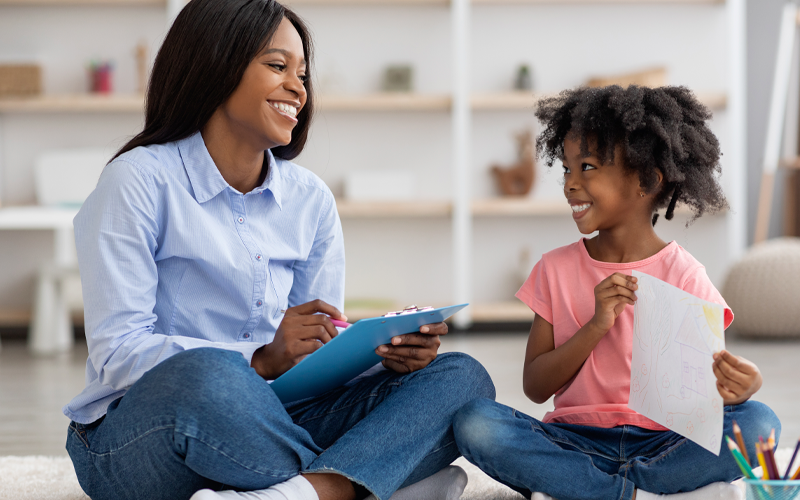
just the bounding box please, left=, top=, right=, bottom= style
left=454, top=86, right=780, bottom=500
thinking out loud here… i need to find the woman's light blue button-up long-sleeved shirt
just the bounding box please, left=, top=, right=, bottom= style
left=63, top=132, right=344, bottom=423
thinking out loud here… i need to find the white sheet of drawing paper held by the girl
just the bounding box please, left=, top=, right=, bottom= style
left=628, top=271, right=725, bottom=455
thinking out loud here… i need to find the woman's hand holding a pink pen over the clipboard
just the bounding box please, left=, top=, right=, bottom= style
left=250, top=300, right=347, bottom=380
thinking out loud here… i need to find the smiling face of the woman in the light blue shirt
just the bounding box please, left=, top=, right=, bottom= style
left=220, top=18, right=307, bottom=149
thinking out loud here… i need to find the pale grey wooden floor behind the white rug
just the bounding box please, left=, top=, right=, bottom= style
left=0, top=333, right=800, bottom=456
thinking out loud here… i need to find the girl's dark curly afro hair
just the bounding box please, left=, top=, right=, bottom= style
left=536, top=85, right=728, bottom=225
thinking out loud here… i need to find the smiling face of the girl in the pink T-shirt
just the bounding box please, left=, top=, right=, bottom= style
left=562, top=135, right=651, bottom=234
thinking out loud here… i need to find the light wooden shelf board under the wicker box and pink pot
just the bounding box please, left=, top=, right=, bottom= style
left=0, top=93, right=144, bottom=113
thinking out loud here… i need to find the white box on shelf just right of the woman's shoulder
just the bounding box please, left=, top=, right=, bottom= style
left=344, top=170, right=415, bottom=201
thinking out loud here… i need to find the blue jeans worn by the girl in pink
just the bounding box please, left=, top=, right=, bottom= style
left=453, top=399, right=781, bottom=500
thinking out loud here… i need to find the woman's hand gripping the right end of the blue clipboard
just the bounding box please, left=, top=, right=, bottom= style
left=375, top=323, right=447, bottom=373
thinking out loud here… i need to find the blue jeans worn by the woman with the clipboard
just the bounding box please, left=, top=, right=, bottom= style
left=67, top=349, right=495, bottom=500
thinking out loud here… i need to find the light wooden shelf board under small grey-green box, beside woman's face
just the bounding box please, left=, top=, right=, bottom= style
left=319, top=92, right=451, bottom=111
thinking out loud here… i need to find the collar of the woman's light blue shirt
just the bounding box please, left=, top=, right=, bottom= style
left=178, top=131, right=283, bottom=208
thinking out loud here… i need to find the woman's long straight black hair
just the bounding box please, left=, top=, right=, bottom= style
left=114, top=0, right=314, bottom=160
